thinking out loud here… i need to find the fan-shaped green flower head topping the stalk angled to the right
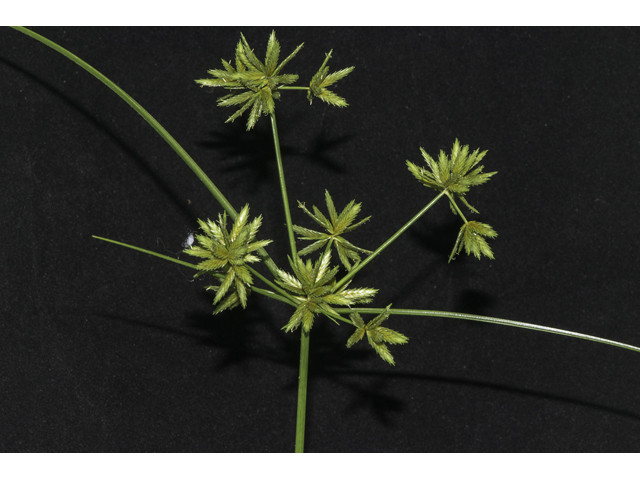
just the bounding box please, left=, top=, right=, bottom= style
left=407, top=139, right=497, bottom=213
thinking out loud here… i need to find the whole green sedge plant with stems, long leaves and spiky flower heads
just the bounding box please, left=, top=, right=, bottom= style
left=14, top=27, right=640, bottom=452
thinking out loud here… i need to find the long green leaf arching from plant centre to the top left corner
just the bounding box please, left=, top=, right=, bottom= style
left=12, top=27, right=277, bottom=275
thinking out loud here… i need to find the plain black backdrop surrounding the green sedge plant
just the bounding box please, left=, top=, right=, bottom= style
left=0, top=27, right=640, bottom=452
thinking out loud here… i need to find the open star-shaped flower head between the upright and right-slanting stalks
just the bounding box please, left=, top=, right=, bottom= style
left=293, top=190, right=371, bottom=270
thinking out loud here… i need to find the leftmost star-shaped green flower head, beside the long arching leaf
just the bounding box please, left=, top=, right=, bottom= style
left=185, top=205, right=271, bottom=315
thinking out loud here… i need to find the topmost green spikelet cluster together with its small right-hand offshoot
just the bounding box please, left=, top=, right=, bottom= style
left=196, top=32, right=354, bottom=130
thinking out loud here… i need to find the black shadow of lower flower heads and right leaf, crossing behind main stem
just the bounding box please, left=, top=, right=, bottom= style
left=101, top=306, right=640, bottom=444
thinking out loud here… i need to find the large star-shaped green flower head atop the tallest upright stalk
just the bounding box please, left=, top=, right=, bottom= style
left=196, top=32, right=302, bottom=130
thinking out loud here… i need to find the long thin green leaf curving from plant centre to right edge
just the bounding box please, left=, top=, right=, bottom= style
left=335, top=308, right=640, bottom=352
